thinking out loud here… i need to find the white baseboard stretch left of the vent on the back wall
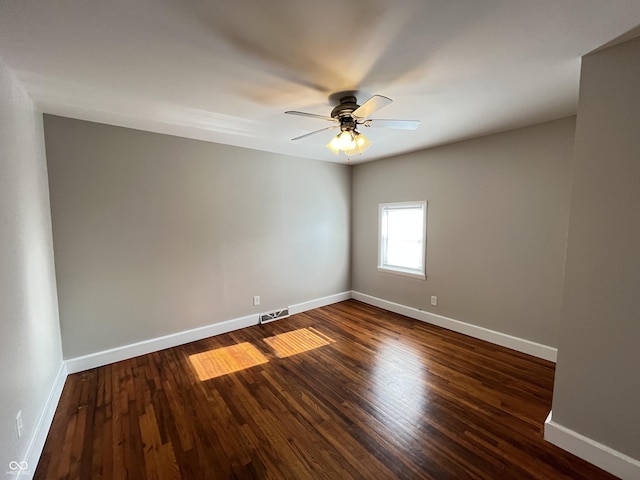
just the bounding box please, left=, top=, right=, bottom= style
left=65, top=314, right=259, bottom=374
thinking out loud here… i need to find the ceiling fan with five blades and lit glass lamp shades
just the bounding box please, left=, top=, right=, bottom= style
left=284, top=93, right=420, bottom=155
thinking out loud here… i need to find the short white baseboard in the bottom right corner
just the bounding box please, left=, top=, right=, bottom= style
left=544, top=412, right=640, bottom=480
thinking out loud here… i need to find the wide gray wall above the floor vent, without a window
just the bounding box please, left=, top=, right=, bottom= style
left=45, top=115, right=351, bottom=358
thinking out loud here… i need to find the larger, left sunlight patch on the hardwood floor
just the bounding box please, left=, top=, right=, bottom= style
left=189, top=342, right=269, bottom=381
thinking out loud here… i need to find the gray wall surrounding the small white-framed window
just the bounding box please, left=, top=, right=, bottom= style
left=352, top=117, right=575, bottom=347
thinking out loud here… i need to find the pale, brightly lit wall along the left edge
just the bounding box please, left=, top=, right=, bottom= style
left=0, top=61, right=62, bottom=468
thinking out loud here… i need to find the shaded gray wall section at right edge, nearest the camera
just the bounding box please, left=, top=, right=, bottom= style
left=553, top=39, right=640, bottom=459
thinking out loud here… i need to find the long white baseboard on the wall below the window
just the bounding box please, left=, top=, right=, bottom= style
left=351, top=291, right=558, bottom=362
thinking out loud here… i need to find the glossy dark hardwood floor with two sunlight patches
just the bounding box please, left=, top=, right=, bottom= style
left=35, top=300, right=614, bottom=480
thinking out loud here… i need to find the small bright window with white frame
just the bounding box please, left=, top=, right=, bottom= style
left=378, top=202, right=427, bottom=279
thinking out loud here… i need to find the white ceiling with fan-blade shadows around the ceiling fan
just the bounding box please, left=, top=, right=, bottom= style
left=0, top=0, right=640, bottom=163
